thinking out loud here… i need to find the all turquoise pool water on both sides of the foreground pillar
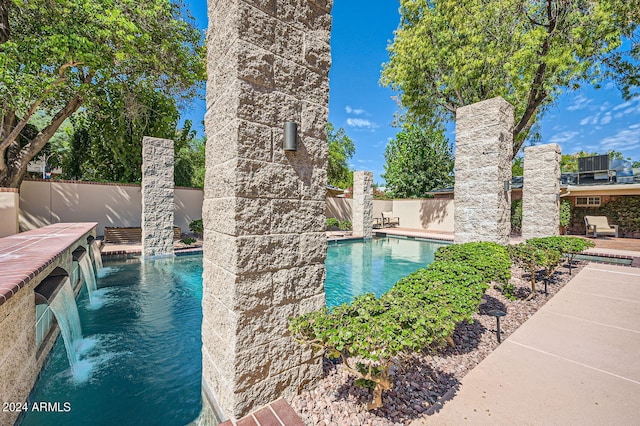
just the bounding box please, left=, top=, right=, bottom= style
left=21, top=238, right=443, bottom=426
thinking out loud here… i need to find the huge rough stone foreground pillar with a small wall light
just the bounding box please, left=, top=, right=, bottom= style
left=202, top=0, right=332, bottom=418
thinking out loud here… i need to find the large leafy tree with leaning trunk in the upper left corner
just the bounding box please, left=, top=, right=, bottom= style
left=0, top=0, right=204, bottom=187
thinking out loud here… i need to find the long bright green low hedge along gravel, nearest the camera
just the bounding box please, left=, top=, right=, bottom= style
left=289, top=243, right=496, bottom=409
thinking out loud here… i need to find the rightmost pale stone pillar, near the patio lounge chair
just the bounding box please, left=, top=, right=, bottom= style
left=522, top=143, right=562, bottom=240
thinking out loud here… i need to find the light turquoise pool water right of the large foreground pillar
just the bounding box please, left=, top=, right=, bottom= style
left=324, top=238, right=447, bottom=308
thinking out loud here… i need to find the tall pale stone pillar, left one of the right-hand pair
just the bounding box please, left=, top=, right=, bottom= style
left=454, top=97, right=513, bottom=244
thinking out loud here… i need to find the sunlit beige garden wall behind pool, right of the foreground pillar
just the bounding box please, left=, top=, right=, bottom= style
left=326, top=197, right=453, bottom=232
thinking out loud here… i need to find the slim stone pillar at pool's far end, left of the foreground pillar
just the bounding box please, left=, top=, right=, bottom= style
left=142, top=136, right=174, bottom=257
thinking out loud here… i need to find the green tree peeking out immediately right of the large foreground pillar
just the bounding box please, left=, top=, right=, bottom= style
left=327, top=123, right=356, bottom=188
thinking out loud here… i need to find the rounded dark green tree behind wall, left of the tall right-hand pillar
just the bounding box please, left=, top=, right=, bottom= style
left=382, top=124, right=454, bottom=198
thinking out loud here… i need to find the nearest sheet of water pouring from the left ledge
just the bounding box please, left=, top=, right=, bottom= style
left=49, top=278, right=82, bottom=370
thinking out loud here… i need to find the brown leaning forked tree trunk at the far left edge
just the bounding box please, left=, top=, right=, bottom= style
left=0, top=95, right=83, bottom=188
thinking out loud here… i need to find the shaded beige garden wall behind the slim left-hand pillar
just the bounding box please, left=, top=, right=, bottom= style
left=20, top=181, right=203, bottom=235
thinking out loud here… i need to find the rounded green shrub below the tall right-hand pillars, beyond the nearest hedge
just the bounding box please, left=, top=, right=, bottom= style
left=435, top=242, right=511, bottom=284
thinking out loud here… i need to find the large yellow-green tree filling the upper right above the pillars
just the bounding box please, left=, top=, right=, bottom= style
left=382, top=0, right=640, bottom=157
